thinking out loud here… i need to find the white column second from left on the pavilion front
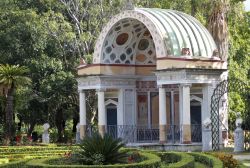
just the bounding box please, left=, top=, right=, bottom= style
left=97, top=90, right=107, bottom=136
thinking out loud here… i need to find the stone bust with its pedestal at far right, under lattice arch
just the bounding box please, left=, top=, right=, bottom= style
left=234, top=113, right=244, bottom=152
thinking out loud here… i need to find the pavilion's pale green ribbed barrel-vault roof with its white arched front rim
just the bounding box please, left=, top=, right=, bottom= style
left=93, top=8, right=216, bottom=64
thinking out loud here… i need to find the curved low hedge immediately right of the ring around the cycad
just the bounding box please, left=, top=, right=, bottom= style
left=158, top=152, right=194, bottom=168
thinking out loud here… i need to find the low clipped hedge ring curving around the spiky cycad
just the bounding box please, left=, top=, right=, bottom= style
left=26, top=152, right=161, bottom=168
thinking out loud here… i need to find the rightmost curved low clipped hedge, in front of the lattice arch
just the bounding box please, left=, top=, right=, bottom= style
left=189, top=152, right=223, bottom=168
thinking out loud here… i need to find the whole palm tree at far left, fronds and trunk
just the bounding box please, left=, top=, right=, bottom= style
left=0, top=64, right=31, bottom=144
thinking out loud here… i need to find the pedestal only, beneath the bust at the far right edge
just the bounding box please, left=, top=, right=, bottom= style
left=234, top=127, right=244, bottom=152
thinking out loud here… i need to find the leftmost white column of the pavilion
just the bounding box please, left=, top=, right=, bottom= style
left=79, top=90, right=86, bottom=139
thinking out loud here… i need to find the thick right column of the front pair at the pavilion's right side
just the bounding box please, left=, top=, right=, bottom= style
left=179, top=84, right=191, bottom=144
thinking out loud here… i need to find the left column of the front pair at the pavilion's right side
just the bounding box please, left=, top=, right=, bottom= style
left=159, top=87, right=167, bottom=143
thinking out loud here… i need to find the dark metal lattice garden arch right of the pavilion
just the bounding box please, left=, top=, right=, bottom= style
left=210, top=78, right=250, bottom=151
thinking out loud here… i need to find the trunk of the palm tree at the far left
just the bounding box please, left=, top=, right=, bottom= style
left=5, top=84, right=14, bottom=145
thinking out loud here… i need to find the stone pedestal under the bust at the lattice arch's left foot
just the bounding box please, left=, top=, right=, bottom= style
left=202, top=128, right=212, bottom=151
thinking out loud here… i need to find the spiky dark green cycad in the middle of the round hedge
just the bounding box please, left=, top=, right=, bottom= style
left=78, top=133, right=127, bottom=165
